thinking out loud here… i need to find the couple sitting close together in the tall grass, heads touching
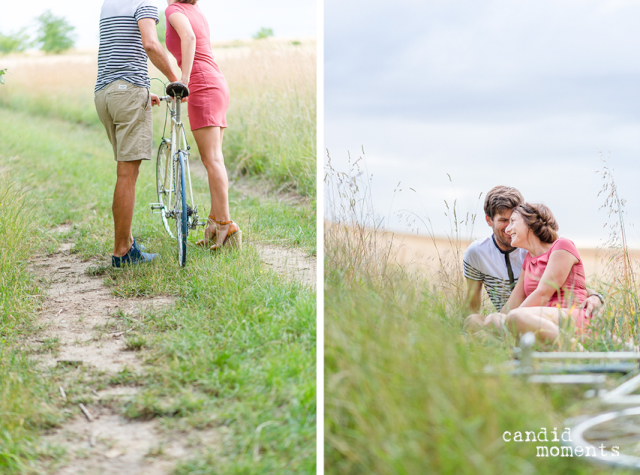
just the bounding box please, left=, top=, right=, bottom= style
left=464, top=186, right=604, bottom=342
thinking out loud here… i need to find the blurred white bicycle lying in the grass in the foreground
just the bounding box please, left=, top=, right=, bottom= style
left=485, top=333, right=640, bottom=469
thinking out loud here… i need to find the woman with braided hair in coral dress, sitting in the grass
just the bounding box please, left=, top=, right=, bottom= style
left=485, top=203, right=590, bottom=342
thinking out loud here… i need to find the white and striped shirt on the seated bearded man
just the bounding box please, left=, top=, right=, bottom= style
left=463, top=235, right=527, bottom=310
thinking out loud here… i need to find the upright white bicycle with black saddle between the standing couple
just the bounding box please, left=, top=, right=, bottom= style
left=151, top=83, right=207, bottom=267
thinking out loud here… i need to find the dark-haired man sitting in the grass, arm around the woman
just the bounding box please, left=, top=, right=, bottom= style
left=463, top=186, right=604, bottom=327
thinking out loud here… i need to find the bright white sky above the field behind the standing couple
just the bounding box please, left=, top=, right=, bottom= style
left=0, top=0, right=317, bottom=48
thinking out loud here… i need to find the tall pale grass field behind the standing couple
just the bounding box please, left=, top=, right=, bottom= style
left=0, top=43, right=317, bottom=199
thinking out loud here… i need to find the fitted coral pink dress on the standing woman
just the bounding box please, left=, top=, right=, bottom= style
left=165, top=3, right=229, bottom=130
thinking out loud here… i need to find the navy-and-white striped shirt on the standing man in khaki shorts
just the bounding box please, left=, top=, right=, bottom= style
left=95, top=0, right=159, bottom=91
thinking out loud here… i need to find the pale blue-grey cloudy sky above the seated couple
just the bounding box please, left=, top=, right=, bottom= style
left=325, top=0, right=640, bottom=246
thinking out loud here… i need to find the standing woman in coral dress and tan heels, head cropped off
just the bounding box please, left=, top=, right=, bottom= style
left=165, top=0, right=242, bottom=250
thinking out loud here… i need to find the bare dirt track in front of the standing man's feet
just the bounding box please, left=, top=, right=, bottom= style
left=26, top=227, right=220, bottom=475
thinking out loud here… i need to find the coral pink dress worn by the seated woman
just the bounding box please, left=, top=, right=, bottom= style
left=521, top=238, right=589, bottom=328
